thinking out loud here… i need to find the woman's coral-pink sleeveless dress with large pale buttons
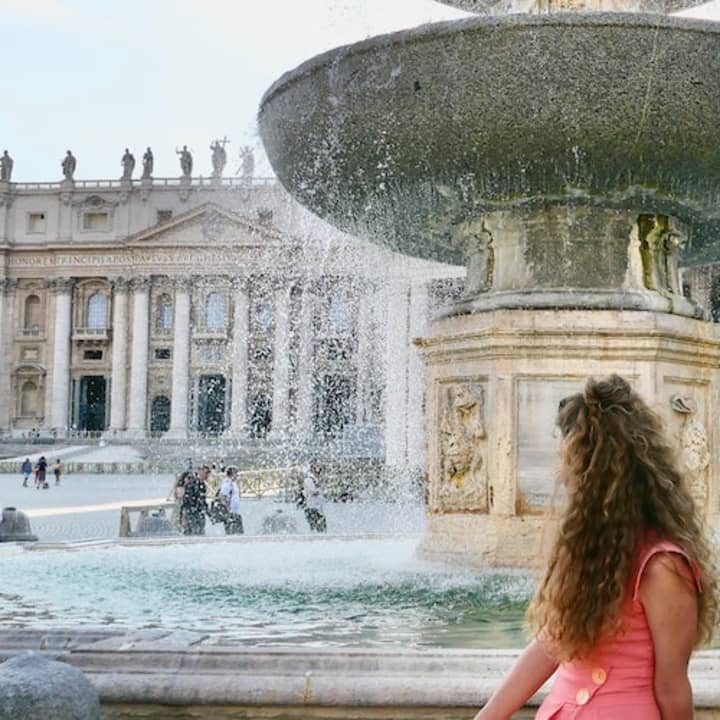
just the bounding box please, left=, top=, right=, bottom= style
left=535, top=541, right=700, bottom=720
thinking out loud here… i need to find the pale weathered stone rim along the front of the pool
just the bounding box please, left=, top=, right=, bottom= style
left=0, top=627, right=720, bottom=717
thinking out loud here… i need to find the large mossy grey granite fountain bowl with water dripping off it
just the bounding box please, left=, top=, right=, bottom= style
left=259, top=13, right=720, bottom=263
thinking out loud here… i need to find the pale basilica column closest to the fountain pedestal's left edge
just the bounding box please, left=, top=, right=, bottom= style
left=407, top=283, right=429, bottom=469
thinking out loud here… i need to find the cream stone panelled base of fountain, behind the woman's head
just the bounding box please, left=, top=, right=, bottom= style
left=420, top=309, right=720, bottom=566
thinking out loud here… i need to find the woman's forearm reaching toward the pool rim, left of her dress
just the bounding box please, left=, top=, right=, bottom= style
left=475, top=639, right=557, bottom=720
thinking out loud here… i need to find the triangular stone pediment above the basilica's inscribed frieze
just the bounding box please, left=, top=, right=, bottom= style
left=123, top=203, right=286, bottom=248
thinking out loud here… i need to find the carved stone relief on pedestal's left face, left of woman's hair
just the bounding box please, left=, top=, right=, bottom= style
left=438, top=383, right=488, bottom=513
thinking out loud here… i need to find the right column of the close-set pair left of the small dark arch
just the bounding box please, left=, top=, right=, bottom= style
left=128, top=277, right=150, bottom=437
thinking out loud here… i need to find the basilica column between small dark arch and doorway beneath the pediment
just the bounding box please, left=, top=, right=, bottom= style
left=167, top=277, right=191, bottom=438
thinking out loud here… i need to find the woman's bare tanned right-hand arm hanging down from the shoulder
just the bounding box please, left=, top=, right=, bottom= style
left=640, top=553, right=698, bottom=720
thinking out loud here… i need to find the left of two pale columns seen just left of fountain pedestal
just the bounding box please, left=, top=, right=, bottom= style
left=385, top=278, right=410, bottom=468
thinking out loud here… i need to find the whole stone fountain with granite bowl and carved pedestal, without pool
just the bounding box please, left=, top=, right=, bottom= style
left=259, top=0, right=720, bottom=566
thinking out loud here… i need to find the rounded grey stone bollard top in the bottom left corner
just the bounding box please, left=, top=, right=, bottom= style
left=0, top=653, right=101, bottom=720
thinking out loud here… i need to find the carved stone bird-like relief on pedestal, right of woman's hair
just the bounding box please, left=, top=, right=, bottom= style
left=670, top=393, right=710, bottom=510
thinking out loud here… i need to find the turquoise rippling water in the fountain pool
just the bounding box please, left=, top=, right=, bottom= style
left=0, top=536, right=533, bottom=649
